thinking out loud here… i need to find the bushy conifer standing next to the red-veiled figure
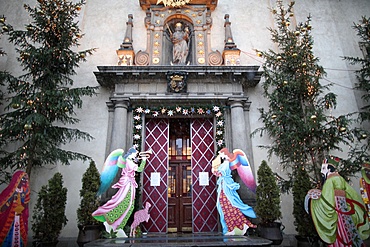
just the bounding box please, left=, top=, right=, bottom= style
left=31, top=172, right=68, bottom=247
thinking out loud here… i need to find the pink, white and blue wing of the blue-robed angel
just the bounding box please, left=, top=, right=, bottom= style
left=230, top=149, right=257, bottom=192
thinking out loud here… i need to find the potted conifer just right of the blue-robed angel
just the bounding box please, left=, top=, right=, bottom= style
left=254, top=160, right=283, bottom=245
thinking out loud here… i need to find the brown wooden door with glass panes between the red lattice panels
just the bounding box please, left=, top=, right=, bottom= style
left=167, top=118, right=192, bottom=232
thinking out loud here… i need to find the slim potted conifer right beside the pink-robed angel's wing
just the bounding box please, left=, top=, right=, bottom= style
left=77, top=161, right=102, bottom=247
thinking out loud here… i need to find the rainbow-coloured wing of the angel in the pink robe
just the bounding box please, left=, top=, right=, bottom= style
left=98, top=149, right=123, bottom=196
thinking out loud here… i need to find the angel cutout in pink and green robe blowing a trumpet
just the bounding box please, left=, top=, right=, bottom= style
left=92, top=147, right=149, bottom=237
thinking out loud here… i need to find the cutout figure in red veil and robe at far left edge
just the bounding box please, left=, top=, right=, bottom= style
left=0, top=171, right=30, bottom=247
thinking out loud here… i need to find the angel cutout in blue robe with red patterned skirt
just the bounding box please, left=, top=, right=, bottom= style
left=212, top=148, right=257, bottom=235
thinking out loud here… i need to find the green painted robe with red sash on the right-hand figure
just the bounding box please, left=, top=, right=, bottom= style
left=310, top=172, right=370, bottom=247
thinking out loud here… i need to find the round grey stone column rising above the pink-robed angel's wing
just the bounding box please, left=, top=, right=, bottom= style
left=110, top=99, right=129, bottom=152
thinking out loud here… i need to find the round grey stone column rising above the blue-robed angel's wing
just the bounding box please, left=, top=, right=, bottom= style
left=229, top=98, right=249, bottom=152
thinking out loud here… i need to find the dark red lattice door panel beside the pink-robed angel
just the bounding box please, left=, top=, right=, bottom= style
left=142, top=119, right=169, bottom=233
